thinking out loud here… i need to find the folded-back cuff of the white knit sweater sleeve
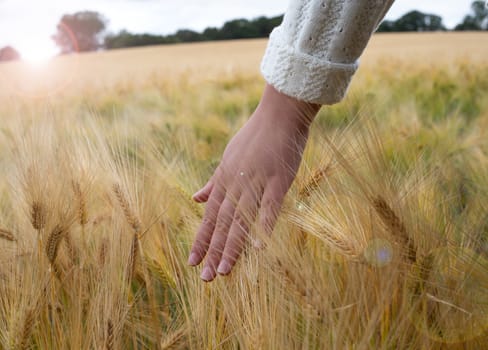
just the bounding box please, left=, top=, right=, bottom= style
left=261, top=27, right=358, bottom=105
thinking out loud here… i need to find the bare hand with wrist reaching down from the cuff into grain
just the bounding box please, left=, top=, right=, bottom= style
left=188, top=85, right=320, bottom=282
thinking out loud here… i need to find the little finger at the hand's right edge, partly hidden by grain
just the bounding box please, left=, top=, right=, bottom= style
left=255, top=181, right=286, bottom=235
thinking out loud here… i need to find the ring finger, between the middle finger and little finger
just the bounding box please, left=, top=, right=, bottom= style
left=217, top=191, right=261, bottom=275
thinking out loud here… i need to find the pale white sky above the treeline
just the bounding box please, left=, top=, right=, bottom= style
left=0, top=0, right=471, bottom=59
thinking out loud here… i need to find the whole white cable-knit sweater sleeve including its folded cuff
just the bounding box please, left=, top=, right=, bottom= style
left=261, top=0, right=394, bottom=104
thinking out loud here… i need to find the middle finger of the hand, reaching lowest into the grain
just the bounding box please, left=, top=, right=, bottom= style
left=200, top=197, right=236, bottom=282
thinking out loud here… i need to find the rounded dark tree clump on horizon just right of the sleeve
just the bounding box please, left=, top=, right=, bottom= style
left=378, top=11, right=446, bottom=32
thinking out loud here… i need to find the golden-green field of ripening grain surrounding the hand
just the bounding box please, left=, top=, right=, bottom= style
left=0, top=33, right=488, bottom=349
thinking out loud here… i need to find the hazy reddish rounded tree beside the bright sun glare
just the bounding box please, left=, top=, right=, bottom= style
left=52, top=11, right=107, bottom=54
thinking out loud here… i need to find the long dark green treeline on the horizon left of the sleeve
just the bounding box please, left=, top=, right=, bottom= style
left=104, top=16, right=283, bottom=49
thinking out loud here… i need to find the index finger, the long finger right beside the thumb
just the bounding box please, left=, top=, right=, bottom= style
left=188, top=187, right=225, bottom=266
